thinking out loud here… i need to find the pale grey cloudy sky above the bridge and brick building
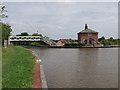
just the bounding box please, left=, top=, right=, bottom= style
left=3, top=2, right=118, bottom=39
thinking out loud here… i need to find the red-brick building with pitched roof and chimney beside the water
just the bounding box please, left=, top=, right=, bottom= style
left=78, top=24, right=98, bottom=45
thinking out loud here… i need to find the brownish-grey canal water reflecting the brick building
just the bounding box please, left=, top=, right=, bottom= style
left=31, top=48, right=118, bottom=88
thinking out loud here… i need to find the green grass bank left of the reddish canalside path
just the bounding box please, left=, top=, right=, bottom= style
left=2, top=46, right=35, bottom=88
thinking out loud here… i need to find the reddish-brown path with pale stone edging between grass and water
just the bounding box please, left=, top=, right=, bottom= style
left=28, top=49, right=48, bottom=88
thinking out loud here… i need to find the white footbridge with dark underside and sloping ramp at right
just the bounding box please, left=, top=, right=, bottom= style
left=8, top=36, right=56, bottom=46
